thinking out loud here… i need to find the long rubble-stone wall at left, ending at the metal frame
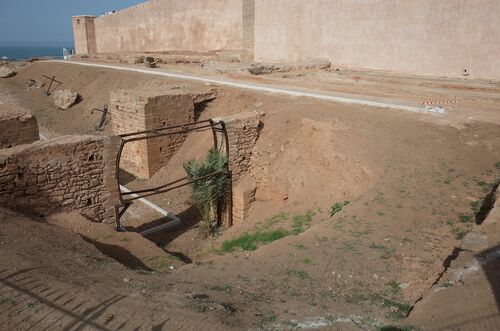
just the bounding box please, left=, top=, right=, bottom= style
left=0, top=135, right=118, bottom=223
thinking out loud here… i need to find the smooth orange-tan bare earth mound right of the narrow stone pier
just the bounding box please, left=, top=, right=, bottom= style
left=252, top=119, right=372, bottom=206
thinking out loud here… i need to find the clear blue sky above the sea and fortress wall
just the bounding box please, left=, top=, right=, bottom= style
left=0, top=0, right=146, bottom=46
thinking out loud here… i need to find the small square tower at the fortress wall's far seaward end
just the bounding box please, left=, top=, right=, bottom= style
left=72, top=15, right=97, bottom=54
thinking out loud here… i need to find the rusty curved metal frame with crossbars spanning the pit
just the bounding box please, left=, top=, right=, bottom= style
left=115, top=120, right=233, bottom=231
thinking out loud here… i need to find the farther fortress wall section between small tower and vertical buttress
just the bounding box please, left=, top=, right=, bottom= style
left=95, top=0, right=242, bottom=53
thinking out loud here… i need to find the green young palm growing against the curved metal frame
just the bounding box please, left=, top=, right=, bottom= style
left=184, top=149, right=229, bottom=237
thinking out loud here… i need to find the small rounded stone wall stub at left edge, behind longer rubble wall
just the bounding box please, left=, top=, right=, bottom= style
left=0, top=105, right=39, bottom=149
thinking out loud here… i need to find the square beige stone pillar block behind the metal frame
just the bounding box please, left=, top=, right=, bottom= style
left=110, top=90, right=194, bottom=178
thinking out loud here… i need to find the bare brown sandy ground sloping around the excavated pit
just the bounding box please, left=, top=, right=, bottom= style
left=0, top=63, right=500, bottom=330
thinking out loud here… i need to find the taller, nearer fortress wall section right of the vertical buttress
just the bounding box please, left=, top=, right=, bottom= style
left=254, top=0, right=500, bottom=79
